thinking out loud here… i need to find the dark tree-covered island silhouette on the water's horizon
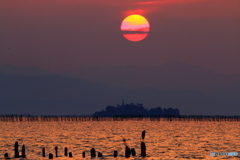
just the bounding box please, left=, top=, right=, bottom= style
left=93, top=101, right=180, bottom=117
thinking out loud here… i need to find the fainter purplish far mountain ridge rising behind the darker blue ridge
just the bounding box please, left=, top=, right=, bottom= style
left=61, top=61, right=240, bottom=91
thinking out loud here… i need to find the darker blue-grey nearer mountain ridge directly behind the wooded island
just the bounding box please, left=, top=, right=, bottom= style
left=0, top=74, right=240, bottom=115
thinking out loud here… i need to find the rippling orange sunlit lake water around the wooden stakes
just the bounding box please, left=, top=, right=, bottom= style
left=0, top=121, right=240, bottom=160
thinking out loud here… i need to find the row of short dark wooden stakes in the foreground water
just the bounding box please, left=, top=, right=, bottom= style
left=4, top=142, right=146, bottom=159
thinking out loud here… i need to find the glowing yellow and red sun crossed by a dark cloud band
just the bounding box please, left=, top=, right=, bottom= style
left=121, top=14, right=150, bottom=42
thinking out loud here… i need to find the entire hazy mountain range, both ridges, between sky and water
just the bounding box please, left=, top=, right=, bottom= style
left=0, top=62, right=240, bottom=115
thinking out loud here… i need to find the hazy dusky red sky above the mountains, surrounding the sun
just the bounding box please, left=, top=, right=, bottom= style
left=0, top=0, right=240, bottom=74
